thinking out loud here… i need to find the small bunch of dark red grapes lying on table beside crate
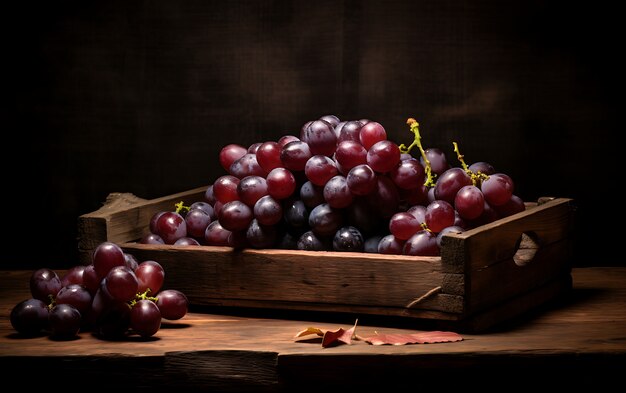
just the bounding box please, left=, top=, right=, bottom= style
left=11, top=242, right=188, bottom=338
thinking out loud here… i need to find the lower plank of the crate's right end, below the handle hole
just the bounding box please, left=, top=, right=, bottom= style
left=466, top=239, right=571, bottom=313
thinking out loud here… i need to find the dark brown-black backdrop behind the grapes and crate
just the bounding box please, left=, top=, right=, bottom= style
left=2, top=0, right=626, bottom=267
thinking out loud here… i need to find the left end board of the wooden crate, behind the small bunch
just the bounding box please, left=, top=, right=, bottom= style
left=78, top=186, right=207, bottom=264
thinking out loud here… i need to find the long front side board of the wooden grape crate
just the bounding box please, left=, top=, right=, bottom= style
left=124, top=244, right=463, bottom=313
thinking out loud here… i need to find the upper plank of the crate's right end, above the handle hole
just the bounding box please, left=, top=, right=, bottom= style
left=441, top=198, right=573, bottom=273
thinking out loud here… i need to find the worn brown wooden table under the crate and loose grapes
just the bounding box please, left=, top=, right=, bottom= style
left=0, top=267, right=626, bottom=392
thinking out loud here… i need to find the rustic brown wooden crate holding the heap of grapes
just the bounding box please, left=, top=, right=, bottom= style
left=78, top=187, right=573, bottom=331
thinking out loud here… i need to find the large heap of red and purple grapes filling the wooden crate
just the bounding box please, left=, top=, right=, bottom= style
left=140, top=115, right=525, bottom=256
